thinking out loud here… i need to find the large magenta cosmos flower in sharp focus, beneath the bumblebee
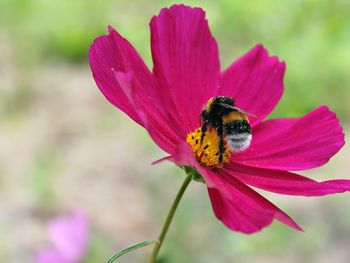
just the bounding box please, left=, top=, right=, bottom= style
left=89, top=5, right=350, bottom=233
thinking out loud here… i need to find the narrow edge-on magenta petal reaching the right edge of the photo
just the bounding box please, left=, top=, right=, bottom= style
left=225, top=163, right=350, bottom=196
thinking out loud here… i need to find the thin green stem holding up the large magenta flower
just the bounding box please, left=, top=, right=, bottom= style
left=148, top=173, right=192, bottom=263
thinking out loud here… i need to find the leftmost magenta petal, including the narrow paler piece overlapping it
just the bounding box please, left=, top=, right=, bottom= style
left=89, top=27, right=185, bottom=153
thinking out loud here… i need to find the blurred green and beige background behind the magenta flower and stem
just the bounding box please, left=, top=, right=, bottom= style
left=0, top=0, right=350, bottom=263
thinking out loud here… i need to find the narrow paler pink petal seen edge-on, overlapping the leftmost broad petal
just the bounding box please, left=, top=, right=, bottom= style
left=115, top=72, right=181, bottom=154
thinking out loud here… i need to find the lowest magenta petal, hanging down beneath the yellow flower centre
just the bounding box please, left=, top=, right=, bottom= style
left=207, top=170, right=302, bottom=234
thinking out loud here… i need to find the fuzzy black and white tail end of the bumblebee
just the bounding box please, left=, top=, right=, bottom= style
left=225, top=120, right=252, bottom=152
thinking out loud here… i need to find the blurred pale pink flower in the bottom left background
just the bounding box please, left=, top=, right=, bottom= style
left=36, top=211, right=89, bottom=263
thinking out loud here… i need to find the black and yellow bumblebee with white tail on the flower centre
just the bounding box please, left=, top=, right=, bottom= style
left=200, top=96, right=252, bottom=164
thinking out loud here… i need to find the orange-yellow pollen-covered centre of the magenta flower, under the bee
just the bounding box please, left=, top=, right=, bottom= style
left=186, top=128, right=232, bottom=169
